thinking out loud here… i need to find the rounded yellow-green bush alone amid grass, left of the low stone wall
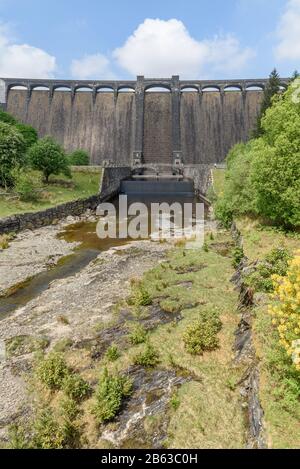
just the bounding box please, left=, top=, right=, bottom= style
left=183, top=312, right=222, bottom=355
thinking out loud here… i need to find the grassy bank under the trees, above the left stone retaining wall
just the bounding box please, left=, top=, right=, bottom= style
left=0, top=172, right=100, bottom=218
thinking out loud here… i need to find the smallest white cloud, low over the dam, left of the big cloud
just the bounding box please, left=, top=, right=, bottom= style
left=71, top=54, right=114, bottom=80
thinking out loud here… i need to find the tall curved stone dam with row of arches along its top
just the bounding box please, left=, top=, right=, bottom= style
left=0, top=76, right=289, bottom=192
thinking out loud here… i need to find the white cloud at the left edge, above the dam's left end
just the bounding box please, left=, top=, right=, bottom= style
left=0, top=24, right=56, bottom=78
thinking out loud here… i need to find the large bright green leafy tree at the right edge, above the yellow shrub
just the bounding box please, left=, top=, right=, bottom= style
left=251, top=87, right=300, bottom=228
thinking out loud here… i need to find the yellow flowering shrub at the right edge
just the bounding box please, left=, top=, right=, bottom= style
left=269, top=251, right=300, bottom=371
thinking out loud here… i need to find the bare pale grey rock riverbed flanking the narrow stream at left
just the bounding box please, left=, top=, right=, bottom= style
left=0, top=214, right=170, bottom=439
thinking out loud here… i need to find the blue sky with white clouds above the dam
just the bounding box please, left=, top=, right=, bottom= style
left=0, top=0, right=300, bottom=80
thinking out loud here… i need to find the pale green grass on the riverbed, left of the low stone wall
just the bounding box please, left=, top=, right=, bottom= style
left=84, top=234, right=245, bottom=448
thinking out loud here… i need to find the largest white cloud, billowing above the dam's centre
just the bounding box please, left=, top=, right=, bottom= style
left=113, top=19, right=255, bottom=78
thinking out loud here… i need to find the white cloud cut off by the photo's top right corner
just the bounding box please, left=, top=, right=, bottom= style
left=275, top=0, right=300, bottom=60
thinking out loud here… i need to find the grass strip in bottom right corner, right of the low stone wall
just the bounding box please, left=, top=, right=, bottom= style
left=254, top=306, right=300, bottom=449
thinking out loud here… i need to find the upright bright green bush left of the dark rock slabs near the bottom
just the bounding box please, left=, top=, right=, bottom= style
left=93, top=368, right=132, bottom=425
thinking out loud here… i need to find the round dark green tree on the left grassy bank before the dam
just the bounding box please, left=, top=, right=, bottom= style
left=28, top=137, right=71, bottom=183
